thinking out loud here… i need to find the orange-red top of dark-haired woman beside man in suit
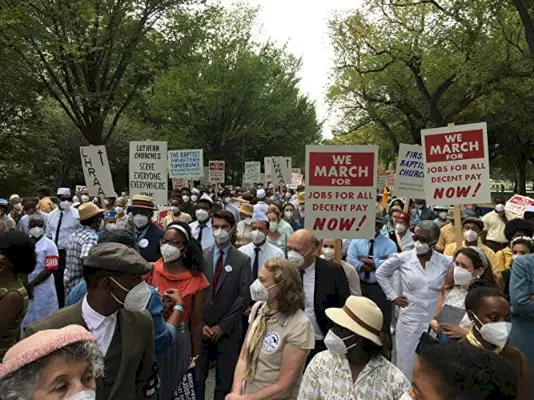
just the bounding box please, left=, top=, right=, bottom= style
left=148, top=258, right=210, bottom=322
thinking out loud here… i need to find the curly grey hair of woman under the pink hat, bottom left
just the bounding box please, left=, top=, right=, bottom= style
left=0, top=341, right=104, bottom=400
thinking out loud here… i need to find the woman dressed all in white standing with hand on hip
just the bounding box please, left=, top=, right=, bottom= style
left=376, top=221, right=454, bottom=381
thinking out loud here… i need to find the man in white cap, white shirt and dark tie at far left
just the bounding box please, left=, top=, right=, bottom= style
left=46, top=188, right=80, bottom=308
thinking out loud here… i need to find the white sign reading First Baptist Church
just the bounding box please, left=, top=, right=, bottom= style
left=392, top=143, right=426, bottom=199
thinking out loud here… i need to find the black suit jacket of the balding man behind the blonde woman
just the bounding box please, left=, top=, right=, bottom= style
left=314, top=257, right=350, bottom=336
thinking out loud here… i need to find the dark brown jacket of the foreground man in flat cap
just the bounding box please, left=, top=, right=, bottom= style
left=24, top=301, right=155, bottom=400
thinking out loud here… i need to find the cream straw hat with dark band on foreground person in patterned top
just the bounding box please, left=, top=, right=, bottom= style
left=325, top=296, right=383, bottom=346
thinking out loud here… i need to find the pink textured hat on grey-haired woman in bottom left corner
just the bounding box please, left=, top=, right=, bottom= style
left=0, top=325, right=95, bottom=379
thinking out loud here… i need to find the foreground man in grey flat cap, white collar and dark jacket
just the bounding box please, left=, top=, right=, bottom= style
left=25, top=243, right=154, bottom=400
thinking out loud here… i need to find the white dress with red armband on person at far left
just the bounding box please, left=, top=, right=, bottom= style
left=21, top=236, right=59, bottom=328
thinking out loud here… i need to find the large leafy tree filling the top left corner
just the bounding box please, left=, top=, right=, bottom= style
left=0, top=0, right=193, bottom=144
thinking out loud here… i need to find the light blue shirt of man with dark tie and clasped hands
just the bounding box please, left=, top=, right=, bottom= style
left=347, top=235, right=397, bottom=283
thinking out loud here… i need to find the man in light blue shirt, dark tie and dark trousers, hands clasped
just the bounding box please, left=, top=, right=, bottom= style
left=347, top=212, right=397, bottom=354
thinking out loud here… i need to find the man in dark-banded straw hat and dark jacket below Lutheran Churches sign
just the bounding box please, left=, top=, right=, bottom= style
left=129, top=194, right=165, bottom=263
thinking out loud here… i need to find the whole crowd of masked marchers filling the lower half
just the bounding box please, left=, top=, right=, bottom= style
left=0, top=185, right=534, bottom=400
